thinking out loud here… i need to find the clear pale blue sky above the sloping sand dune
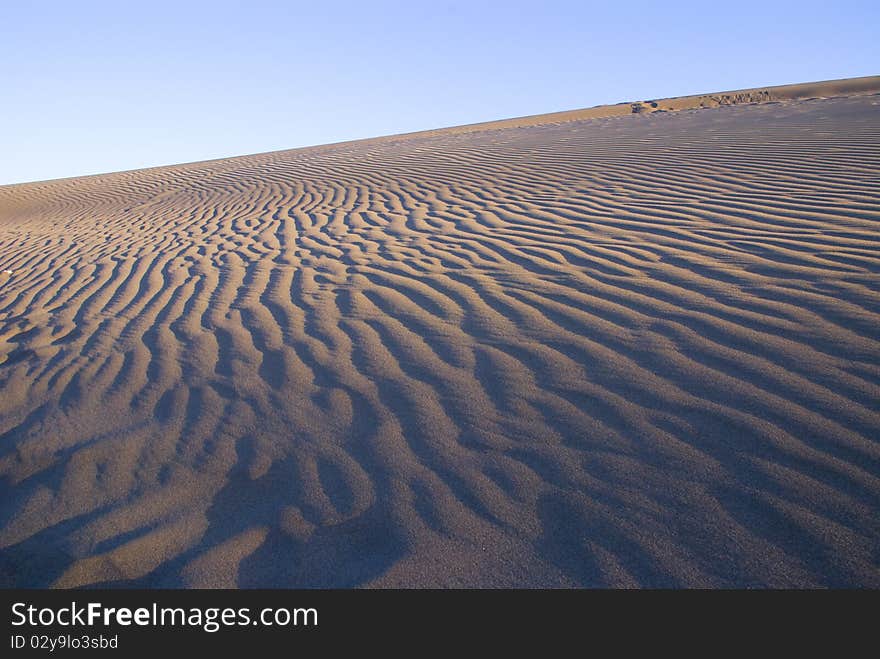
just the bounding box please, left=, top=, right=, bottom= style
left=0, top=0, right=880, bottom=184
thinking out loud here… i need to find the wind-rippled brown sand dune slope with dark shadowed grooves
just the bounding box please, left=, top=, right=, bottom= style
left=0, top=79, right=880, bottom=587
